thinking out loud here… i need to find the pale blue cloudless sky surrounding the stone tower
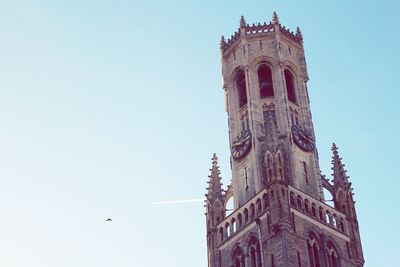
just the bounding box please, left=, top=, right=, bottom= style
left=0, top=0, right=400, bottom=267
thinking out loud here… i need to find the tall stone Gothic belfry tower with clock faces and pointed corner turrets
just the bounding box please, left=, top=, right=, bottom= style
left=206, top=13, right=364, bottom=267
